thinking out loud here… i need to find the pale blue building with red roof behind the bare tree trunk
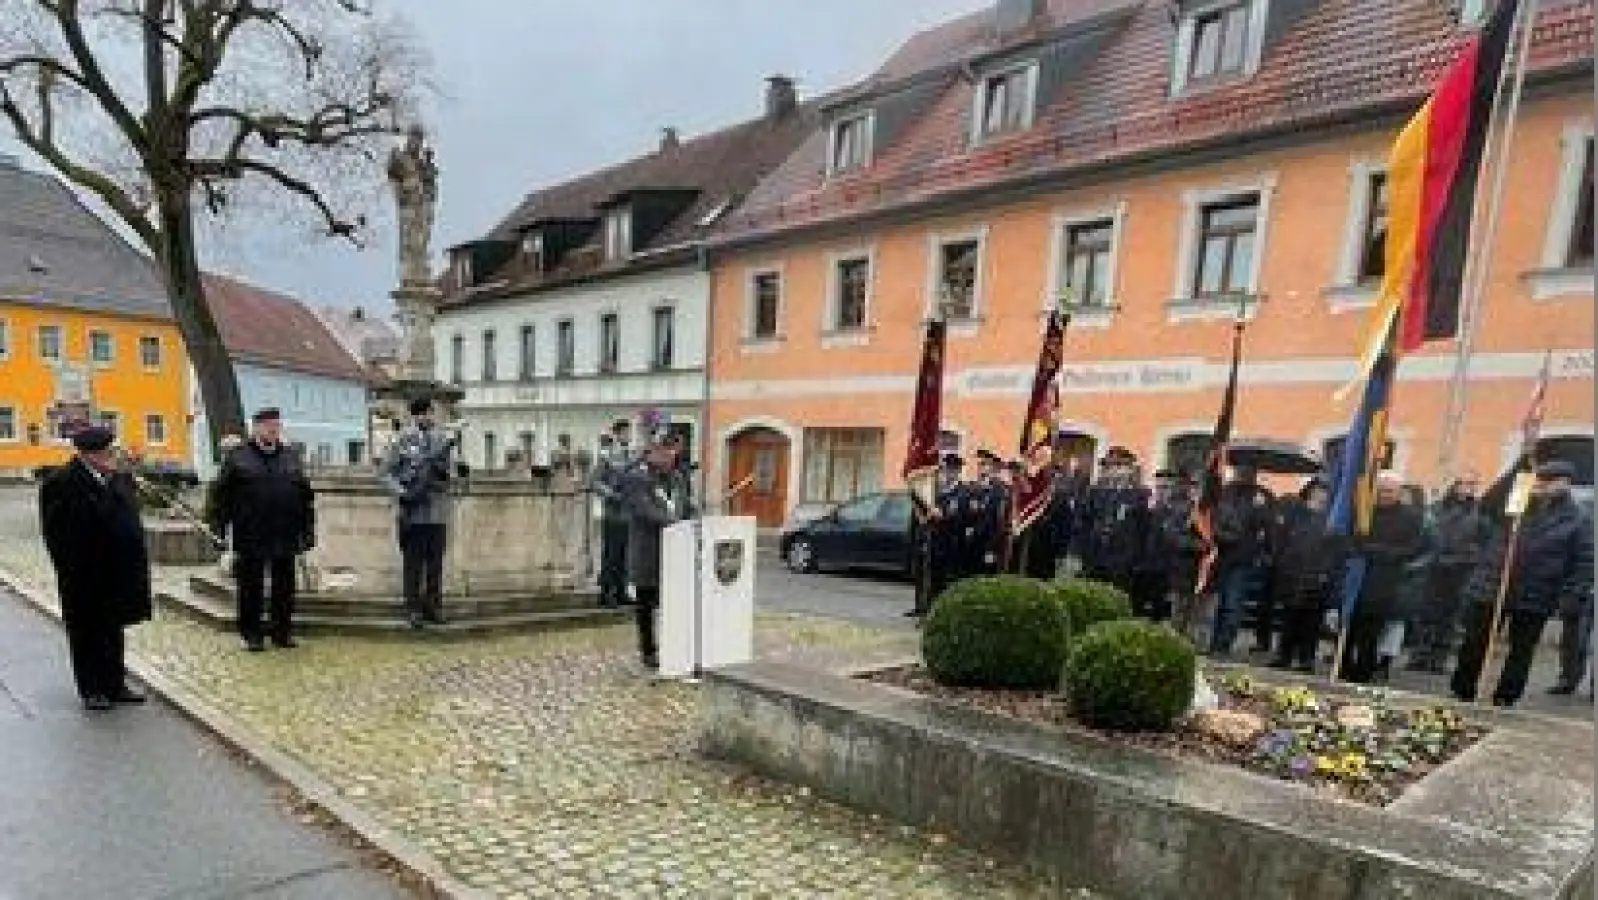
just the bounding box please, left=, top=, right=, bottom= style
left=193, top=275, right=368, bottom=475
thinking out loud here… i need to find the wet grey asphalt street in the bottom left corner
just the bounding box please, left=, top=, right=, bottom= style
left=0, top=590, right=407, bottom=900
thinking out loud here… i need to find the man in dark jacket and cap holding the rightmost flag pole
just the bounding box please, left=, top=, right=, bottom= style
left=1453, top=462, right=1593, bottom=707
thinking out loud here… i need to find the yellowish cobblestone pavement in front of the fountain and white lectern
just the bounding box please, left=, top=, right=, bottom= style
left=0, top=492, right=1073, bottom=898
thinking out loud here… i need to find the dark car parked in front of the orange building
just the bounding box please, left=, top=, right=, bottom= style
left=780, top=491, right=914, bottom=577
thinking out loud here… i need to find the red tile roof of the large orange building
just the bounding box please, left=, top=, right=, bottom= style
left=718, top=0, right=1593, bottom=243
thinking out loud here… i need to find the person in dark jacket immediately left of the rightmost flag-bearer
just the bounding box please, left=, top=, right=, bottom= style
left=1408, top=475, right=1489, bottom=673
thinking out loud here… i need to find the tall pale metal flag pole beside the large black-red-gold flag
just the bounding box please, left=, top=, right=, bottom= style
left=1437, top=0, right=1537, bottom=484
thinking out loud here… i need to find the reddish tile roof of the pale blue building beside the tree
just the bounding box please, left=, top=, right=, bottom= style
left=205, top=273, right=366, bottom=380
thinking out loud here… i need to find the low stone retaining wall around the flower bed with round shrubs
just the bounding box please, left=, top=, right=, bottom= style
left=703, top=663, right=1593, bottom=900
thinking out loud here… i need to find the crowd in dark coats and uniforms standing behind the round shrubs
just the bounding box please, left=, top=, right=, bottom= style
left=911, top=431, right=1593, bottom=707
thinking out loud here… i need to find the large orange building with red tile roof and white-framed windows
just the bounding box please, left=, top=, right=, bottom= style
left=706, top=0, right=1593, bottom=526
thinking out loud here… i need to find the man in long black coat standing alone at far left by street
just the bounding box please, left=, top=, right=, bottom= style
left=38, top=427, right=150, bottom=711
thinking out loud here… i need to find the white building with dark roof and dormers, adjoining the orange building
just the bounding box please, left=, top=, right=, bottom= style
left=433, top=77, right=817, bottom=468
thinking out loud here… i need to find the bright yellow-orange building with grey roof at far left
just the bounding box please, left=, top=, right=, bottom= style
left=0, top=157, right=190, bottom=473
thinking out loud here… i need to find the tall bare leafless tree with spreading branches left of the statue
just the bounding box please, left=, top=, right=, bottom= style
left=0, top=0, right=427, bottom=448
